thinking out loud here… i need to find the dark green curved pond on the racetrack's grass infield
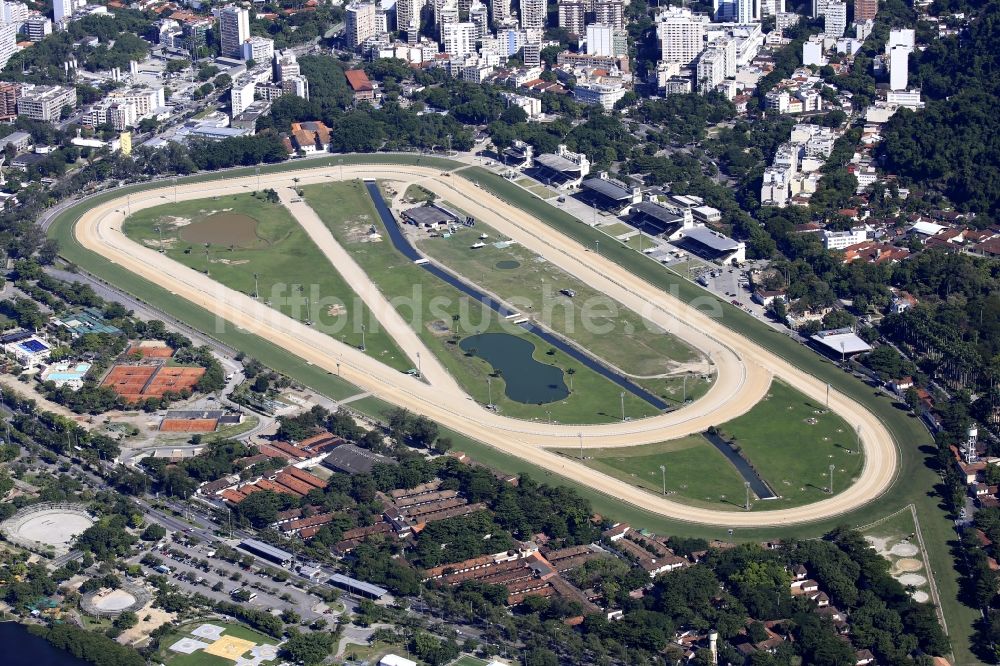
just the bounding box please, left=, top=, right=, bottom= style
left=458, top=333, right=569, bottom=405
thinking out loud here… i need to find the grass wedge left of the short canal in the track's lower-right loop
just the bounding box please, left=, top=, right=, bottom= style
left=555, top=435, right=745, bottom=509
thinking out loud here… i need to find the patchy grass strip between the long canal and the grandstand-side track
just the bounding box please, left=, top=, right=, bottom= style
left=416, top=223, right=700, bottom=378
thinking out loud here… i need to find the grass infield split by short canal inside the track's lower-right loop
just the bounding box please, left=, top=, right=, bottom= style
left=558, top=382, right=863, bottom=511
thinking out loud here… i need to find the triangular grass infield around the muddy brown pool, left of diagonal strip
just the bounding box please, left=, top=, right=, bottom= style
left=123, top=189, right=413, bottom=370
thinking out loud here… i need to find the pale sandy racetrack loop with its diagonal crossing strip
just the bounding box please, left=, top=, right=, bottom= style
left=73, top=158, right=899, bottom=527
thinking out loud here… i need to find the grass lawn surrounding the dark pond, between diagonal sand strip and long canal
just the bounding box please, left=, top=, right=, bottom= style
left=303, top=181, right=656, bottom=423
